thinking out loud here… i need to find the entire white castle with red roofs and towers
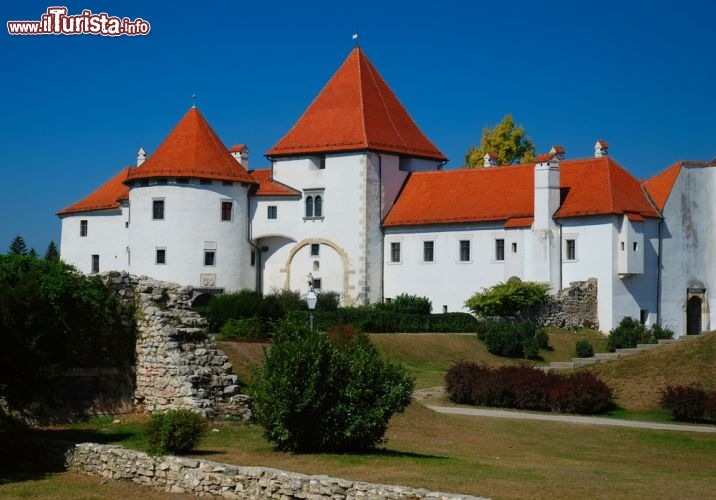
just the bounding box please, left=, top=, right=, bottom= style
left=58, top=47, right=716, bottom=335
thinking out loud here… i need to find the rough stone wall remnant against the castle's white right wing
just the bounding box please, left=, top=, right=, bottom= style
left=537, top=278, right=599, bottom=330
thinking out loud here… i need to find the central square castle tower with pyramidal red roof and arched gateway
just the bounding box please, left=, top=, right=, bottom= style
left=252, top=47, right=446, bottom=304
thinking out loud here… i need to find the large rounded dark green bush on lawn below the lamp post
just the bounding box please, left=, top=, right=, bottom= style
left=250, top=321, right=413, bottom=452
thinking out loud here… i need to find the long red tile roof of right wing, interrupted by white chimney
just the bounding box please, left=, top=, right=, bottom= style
left=383, top=157, right=658, bottom=227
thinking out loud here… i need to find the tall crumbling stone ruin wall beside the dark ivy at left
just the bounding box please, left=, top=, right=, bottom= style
left=103, top=272, right=251, bottom=420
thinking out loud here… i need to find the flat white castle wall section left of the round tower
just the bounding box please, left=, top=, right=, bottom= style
left=60, top=206, right=129, bottom=274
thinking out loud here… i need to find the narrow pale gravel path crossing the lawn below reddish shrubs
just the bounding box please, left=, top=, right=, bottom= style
left=426, top=405, right=716, bottom=432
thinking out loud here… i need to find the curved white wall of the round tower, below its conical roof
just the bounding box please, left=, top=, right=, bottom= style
left=129, top=179, right=255, bottom=291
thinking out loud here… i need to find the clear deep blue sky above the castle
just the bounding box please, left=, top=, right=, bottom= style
left=0, top=0, right=716, bottom=253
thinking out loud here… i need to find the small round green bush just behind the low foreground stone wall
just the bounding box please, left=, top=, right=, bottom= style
left=144, top=409, right=206, bottom=455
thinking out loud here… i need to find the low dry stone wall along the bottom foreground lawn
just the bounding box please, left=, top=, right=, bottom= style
left=66, top=443, right=480, bottom=500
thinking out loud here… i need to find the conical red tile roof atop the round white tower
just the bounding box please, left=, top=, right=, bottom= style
left=127, top=108, right=254, bottom=183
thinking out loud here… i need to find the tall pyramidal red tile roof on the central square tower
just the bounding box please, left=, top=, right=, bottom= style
left=266, top=47, right=447, bottom=160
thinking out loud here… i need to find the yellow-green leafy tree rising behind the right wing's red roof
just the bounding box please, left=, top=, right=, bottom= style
left=463, top=114, right=535, bottom=168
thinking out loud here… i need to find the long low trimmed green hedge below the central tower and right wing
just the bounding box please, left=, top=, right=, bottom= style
left=287, top=306, right=478, bottom=333
